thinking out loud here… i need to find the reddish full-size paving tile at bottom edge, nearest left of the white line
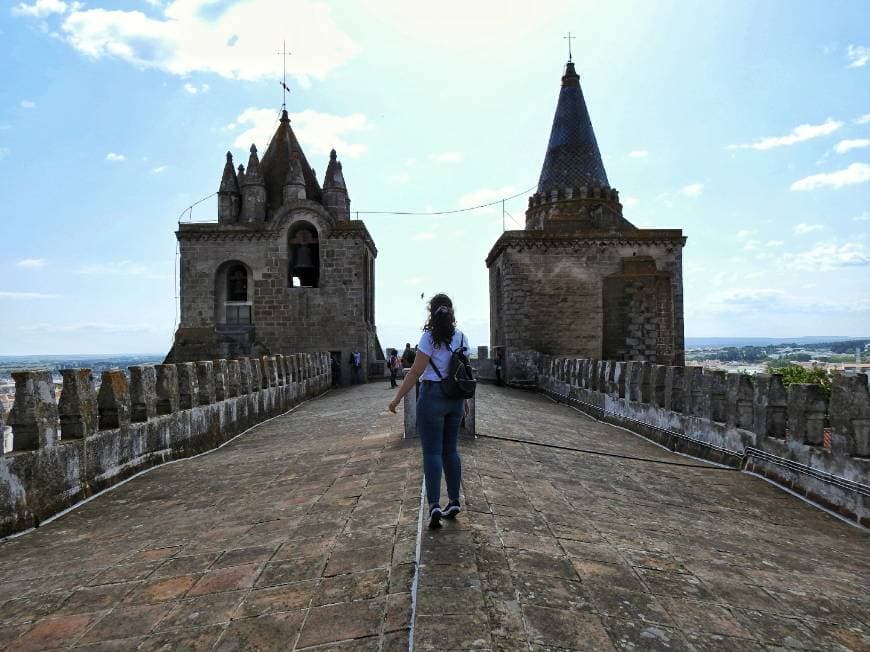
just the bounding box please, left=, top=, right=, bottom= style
left=297, top=598, right=387, bottom=648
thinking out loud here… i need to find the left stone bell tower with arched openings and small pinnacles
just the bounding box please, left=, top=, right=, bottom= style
left=167, top=111, right=383, bottom=382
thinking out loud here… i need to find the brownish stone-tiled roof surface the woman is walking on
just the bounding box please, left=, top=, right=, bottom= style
left=0, top=384, right=870, bottom=652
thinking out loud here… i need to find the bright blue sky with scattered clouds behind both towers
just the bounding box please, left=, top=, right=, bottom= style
left=0, top=0, right=870, bottom=354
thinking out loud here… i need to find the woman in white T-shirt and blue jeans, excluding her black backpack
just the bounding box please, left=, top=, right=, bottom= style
left=389, top=294, right=468, bottom=527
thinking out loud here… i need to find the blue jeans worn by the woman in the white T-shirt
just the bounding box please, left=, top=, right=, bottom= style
left=417, top=382, right=465, bottom=505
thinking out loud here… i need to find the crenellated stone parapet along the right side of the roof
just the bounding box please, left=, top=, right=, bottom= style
left=540, top=352, right=870, bottom=524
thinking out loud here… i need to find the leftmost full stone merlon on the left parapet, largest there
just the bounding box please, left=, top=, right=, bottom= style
left=9, top=371, right=57, bottom=451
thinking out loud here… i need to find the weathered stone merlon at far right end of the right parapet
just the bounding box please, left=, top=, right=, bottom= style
left=830, top=374, right=870, bottom=457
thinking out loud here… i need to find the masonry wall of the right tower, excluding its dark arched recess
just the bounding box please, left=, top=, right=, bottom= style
left=489, top=239, right=683, bottom=364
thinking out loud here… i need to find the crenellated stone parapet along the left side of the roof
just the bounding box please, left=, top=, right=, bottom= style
left=0, top=353, right=332, bottom=536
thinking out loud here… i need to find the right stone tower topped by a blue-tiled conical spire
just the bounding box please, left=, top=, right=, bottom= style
left=486, top=61, right=685, bottom=381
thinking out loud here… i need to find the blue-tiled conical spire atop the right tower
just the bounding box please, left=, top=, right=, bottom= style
left=538, top=61, right=610, bottom=197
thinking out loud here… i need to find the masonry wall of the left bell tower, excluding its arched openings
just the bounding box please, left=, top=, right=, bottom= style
left=176, top=209, right=378, bottom=382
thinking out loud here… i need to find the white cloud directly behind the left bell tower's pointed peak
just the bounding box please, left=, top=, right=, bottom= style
left=233, top=107, right=372, bottom=158
